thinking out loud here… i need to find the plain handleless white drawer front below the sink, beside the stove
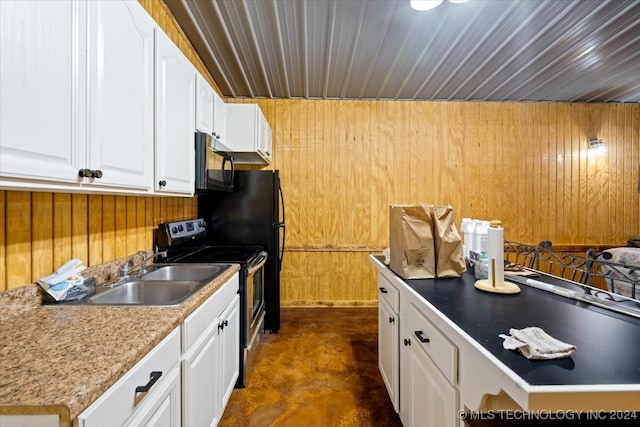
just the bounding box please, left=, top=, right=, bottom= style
left=182, top=273, right=239, bottom=353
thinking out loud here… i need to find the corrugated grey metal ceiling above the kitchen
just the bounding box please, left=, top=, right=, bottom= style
left=165, top=0, right=640, bottom=102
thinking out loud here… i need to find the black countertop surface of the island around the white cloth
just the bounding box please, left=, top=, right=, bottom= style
left=401, top=272, right=640, bottom=386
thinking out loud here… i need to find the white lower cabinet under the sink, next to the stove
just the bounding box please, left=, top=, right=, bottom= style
left=182, top=274, right=240, bottom=427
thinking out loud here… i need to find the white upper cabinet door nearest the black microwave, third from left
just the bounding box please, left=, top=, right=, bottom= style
left=155, top=28, right=196, bottom=194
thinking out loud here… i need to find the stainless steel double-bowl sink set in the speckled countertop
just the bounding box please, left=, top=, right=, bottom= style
left=49, top=264, right=230, bottom=307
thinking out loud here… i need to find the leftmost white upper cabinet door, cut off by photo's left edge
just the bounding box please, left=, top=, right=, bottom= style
left=0, top=0, right=86, bottom=183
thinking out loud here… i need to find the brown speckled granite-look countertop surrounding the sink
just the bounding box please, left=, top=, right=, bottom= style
left=0, top=264, right=239, bottom=423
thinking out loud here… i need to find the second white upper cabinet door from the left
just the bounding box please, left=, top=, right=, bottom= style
left=86, top=0, right=155, bottom=191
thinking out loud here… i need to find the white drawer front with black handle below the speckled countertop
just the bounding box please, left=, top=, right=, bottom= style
left=78, top=328, right=180, bottom=427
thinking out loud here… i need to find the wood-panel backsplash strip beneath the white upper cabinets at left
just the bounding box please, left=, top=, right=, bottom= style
left=0, top=191, right=197, bottom=291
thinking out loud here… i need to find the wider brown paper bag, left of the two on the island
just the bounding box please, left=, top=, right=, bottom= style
left=389, top=205, right=436, bottom=279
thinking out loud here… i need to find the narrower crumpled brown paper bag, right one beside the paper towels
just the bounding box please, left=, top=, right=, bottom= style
left=431, top=205, right=467, bottom=277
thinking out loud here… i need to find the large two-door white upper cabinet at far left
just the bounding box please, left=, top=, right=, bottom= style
left=0, top=1, right=155, bottom=194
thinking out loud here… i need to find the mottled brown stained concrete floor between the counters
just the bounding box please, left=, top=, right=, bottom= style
left=219, top=307, right=401, bottom=427
